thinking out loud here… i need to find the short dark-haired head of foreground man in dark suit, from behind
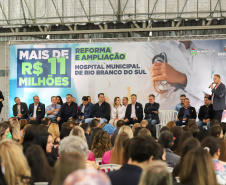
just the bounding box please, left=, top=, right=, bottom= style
left=128, top=136, right=158, bottom=167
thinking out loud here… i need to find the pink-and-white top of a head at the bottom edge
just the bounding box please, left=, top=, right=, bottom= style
left=64, top=169, right=111, bottom=185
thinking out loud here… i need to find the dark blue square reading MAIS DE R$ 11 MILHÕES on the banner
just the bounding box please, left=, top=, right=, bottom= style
left=17, top=48, right=71, bottom=88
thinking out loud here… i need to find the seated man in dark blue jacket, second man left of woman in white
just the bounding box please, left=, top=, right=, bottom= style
left=76, top=96, right=92, bottom=123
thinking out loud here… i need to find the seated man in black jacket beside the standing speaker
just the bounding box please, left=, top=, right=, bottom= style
left=198, top=97, right=213, bottom=130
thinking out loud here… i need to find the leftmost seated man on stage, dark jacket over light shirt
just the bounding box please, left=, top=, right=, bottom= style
left=13, top=97, right=28, bottom=120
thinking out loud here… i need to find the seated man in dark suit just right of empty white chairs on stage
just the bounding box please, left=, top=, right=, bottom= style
left=176, top=98, right=197, bottom=126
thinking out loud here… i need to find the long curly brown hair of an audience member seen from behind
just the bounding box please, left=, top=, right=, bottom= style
left=91, top=130, right=112, bottom=158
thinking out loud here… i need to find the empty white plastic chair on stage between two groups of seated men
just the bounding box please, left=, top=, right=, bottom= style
left=156, top=110, right=178, bottom=138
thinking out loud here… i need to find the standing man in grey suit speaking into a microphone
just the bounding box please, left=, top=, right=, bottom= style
left=210, top=74, right=226, bottom=122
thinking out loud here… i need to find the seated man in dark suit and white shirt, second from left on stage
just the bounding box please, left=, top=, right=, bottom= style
left=28, top=95, right=45, bottom=123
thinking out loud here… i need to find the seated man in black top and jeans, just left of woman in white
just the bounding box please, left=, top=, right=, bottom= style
left=85, top=93, right=111, bottom=124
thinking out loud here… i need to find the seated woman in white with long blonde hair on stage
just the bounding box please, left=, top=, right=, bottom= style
left=109, top=97, right=126, bottom=127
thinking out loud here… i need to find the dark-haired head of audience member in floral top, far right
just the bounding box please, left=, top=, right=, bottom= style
left=201, top=136, right=220, bottom=159
